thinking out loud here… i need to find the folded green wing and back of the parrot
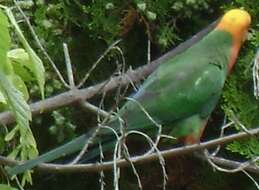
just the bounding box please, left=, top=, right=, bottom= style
left=120, top=30, right=231, bottom=132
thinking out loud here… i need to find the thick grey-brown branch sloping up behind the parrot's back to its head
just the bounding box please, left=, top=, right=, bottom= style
left=0, top=21, right=217, bottom=125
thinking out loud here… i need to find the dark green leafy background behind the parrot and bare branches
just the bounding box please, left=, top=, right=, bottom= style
left=0, top=0, right=259, bottom=190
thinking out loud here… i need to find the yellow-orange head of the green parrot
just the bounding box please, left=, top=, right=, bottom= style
left=216, top=9, right=251, bottom=44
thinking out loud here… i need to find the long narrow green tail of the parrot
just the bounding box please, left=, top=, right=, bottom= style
left=7, top=116, right=122, bottom=175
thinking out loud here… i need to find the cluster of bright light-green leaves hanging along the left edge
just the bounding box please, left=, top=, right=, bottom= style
left=0, top=5, right=44, bottom=184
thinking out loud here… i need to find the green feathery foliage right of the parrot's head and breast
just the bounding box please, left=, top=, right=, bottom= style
left=221, top=0, right=259, bottom=158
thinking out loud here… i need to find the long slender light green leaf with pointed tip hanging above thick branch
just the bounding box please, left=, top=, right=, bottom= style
left=6, top=9, right=45, bottom=98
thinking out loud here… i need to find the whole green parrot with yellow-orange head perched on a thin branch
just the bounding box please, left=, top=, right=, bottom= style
left=8, top=9, right=251, bottom=175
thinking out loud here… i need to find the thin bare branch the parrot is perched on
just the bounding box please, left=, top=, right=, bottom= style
left=29, top=128, right=259, bottom=173
